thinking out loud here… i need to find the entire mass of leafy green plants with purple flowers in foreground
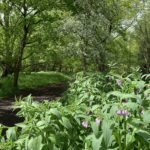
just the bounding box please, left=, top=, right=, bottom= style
left=0, top=73, right=150, bottom=150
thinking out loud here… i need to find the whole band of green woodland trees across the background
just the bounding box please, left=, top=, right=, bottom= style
left=0, top=0, right=150, bottom=87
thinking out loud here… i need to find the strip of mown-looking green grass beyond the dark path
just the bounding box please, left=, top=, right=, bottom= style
left=0, top=72, right=70, bottom=98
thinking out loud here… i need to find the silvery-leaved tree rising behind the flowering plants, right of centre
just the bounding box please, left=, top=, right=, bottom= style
left=63, top=0, right=140, bottom=72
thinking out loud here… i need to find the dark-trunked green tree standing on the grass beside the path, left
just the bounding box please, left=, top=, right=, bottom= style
left=0, top=0, right=63, bottom=87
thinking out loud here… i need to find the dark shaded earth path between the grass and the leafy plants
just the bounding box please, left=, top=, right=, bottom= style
left=0, top=83, right=68, bottom=126
